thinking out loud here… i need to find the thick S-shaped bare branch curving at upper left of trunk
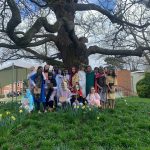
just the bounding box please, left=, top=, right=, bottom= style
left=6, top=0, right=60, bottom=47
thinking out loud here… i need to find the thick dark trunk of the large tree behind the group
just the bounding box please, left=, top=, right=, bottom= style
left=54, top=2, right=88, bottom=68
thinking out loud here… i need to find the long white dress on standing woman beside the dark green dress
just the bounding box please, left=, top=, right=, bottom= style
left=78, top=70, right=86, bottom=98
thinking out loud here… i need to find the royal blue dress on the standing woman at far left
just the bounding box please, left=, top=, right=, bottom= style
left=31, top=73, right=46, bottom=102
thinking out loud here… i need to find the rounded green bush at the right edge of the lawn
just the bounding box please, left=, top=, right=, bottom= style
left=136, top=72, right=150, bottom=98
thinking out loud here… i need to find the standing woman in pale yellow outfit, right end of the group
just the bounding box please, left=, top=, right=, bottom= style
left=106, top=69, right=117, bottom=109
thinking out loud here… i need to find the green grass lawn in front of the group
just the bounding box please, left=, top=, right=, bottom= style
left=0, top=97, right=150, bottom=150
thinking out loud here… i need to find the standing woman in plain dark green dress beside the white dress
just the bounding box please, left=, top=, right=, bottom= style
left=86, top=66, right=94, bottom=94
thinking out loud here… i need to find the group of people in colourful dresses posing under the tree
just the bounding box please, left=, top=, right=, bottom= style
left=23, top=65, right=117, bottom=113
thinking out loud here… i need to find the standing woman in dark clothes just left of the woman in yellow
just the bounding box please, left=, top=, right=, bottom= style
left=98, top=67, right=107, bottom=109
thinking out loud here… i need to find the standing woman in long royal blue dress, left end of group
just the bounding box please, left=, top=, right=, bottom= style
left=31, top=66, right=46, bottom=113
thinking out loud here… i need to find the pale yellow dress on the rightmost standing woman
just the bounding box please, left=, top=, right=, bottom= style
left=106, top=76, right=117, bottom=100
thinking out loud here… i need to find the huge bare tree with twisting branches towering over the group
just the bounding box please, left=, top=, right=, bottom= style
left=0, top=0, right=150, bottom=67
